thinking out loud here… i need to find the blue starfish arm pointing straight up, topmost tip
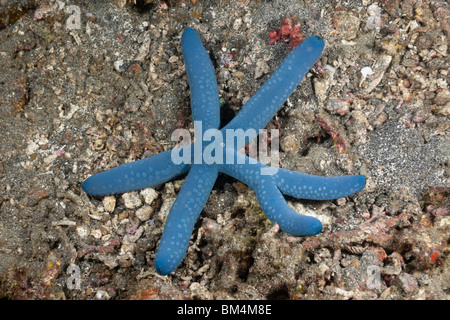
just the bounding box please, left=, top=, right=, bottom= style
left=181, top=28, right=220, bottom=132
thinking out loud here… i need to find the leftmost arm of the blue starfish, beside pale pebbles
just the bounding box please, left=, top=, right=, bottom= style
left=81, top=146, right=190, bottom=196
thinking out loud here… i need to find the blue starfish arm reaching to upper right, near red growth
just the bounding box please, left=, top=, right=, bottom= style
left=224, top=36, right=324, bottom=149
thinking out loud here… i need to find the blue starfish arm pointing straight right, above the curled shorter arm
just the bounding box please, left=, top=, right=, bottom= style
left=276, top=169, right=366, bottom=200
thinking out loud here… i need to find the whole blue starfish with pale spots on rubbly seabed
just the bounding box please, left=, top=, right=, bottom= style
left=82, top=28, right=366, bottom=275
